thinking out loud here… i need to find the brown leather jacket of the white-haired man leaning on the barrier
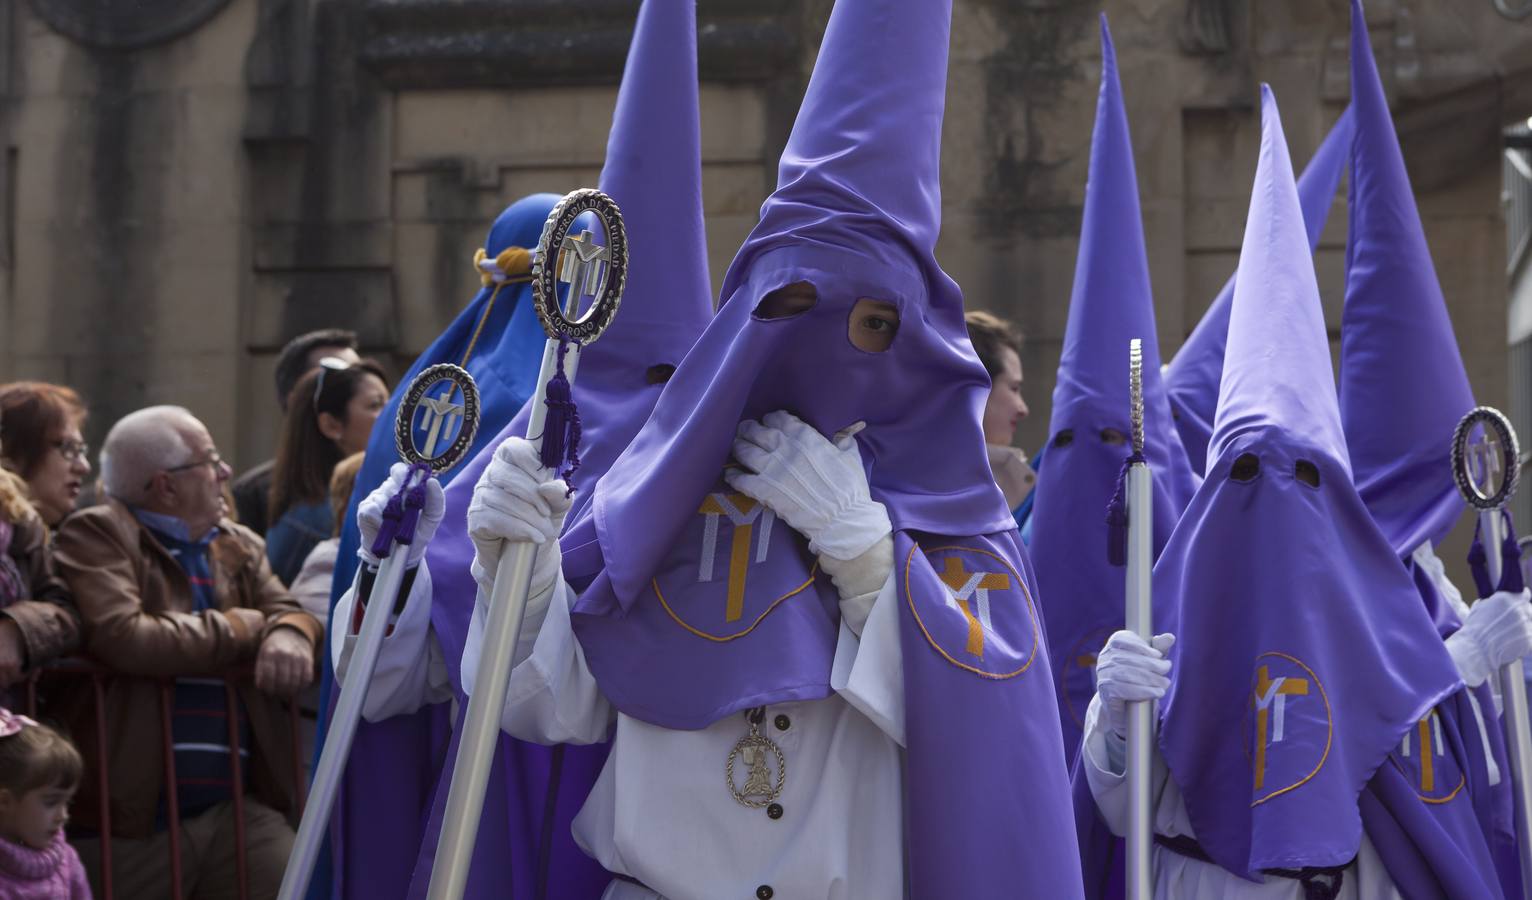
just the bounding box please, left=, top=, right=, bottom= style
left=54, top=500, right=323, bottom=837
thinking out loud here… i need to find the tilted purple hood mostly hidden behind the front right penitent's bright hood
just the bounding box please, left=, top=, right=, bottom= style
left=1164, top=107, right=1354, bottom=475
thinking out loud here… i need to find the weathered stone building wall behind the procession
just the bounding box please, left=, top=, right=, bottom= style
left=0, top=0, right=1532, bottom=570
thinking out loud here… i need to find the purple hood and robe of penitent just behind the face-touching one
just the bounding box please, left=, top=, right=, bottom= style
left=411, top=0, right=712, bottom=900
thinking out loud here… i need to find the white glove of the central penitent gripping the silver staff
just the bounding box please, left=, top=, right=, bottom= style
left=469, top=437, right=570, bottom=596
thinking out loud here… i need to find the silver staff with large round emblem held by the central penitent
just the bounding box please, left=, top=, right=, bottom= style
left=427, top=189, right=628, bottom=900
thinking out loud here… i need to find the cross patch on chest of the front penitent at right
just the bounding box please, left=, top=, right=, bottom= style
left=1244, top=652, right=1334, bottom=806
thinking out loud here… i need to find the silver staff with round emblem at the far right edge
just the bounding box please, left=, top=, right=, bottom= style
left=1452, top=406, right=1532, bottom=897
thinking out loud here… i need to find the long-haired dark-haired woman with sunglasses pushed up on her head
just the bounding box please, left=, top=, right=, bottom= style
left=267, top=357, right=388, bottom=584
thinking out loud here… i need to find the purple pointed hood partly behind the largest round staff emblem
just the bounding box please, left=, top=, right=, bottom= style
left=427, top=0, right=712, bottom=684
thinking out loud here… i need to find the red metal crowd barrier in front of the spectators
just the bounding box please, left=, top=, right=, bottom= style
left=26, top=659, right=308, bottom=900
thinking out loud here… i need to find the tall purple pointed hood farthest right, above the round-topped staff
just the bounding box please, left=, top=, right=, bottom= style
left=1341, top=0, right=1474, bottom=557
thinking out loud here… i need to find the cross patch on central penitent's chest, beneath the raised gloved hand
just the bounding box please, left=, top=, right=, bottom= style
left=651, top=478, right=840, bottom=641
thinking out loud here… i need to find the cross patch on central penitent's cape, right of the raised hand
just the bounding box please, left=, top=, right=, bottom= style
left=901, top=544, right=1037, bottom=679
